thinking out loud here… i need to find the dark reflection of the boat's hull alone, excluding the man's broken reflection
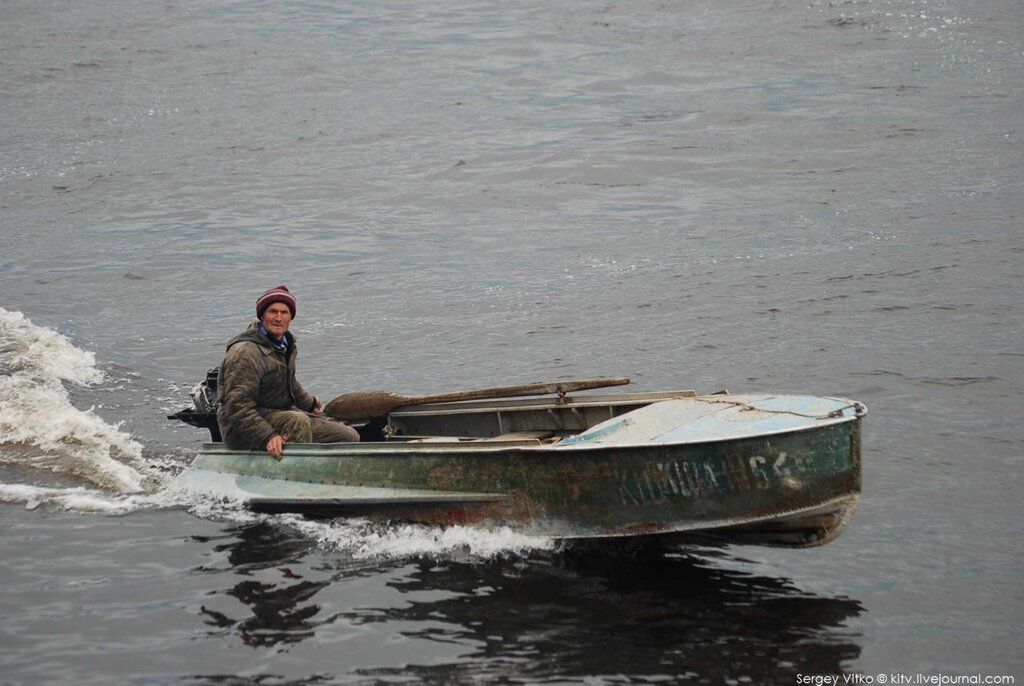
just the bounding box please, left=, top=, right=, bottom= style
left=368, top=555, right=861, bottom=683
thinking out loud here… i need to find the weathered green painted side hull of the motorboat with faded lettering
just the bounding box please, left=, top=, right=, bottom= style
left=179, top=417, right=860, bottom=547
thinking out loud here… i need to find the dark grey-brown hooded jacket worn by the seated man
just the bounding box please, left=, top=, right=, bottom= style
left=217, top=321, right=316, bottom=449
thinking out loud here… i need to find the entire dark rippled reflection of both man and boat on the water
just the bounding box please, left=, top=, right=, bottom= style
left=195, top=523, right=862, bottom=683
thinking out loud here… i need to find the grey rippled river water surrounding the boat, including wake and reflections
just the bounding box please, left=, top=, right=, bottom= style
left=0, top=0, right=1024, bottom=685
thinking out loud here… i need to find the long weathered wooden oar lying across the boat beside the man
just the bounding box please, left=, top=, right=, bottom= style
left=324, top=377, right=630, bottom=420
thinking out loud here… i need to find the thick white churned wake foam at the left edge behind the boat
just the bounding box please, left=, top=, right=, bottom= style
left=0, top=307, right=146, bottom=491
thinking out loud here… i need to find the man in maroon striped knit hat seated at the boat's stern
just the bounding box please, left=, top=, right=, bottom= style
left=217, top=286, right=359, bottom=460
